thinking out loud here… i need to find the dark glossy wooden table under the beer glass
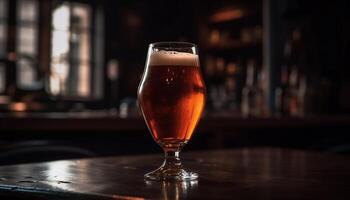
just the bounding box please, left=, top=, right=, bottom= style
left=0, top=148, right=350, bottom=200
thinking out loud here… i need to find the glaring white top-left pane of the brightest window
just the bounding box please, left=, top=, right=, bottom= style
left=52, top=3, right=70, bottom=31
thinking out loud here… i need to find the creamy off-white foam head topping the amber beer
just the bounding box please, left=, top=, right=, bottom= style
left=149, top=51, right=199, bottom=67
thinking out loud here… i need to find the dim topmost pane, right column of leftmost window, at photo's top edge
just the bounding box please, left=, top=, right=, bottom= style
left=17, top=0, right=39, bottom=22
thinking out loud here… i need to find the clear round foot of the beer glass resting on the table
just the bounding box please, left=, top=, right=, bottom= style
left=145, top=167, right=198, bottom=181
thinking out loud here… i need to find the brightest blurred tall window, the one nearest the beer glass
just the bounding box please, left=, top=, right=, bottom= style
left=50, top=2, right=93, bottom=97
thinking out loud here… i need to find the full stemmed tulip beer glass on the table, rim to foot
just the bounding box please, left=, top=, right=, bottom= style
left=138, top=42, right=205, bottom=181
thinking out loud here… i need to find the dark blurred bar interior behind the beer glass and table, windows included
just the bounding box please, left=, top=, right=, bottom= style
left=0, top=0, right=350, bottom=164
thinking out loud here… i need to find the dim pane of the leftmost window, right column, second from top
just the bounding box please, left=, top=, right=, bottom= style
left=17, top=26, right=37, bottom=55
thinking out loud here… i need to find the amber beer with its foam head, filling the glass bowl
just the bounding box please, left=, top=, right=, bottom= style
left=139, top=52, right=205, bottom=145
